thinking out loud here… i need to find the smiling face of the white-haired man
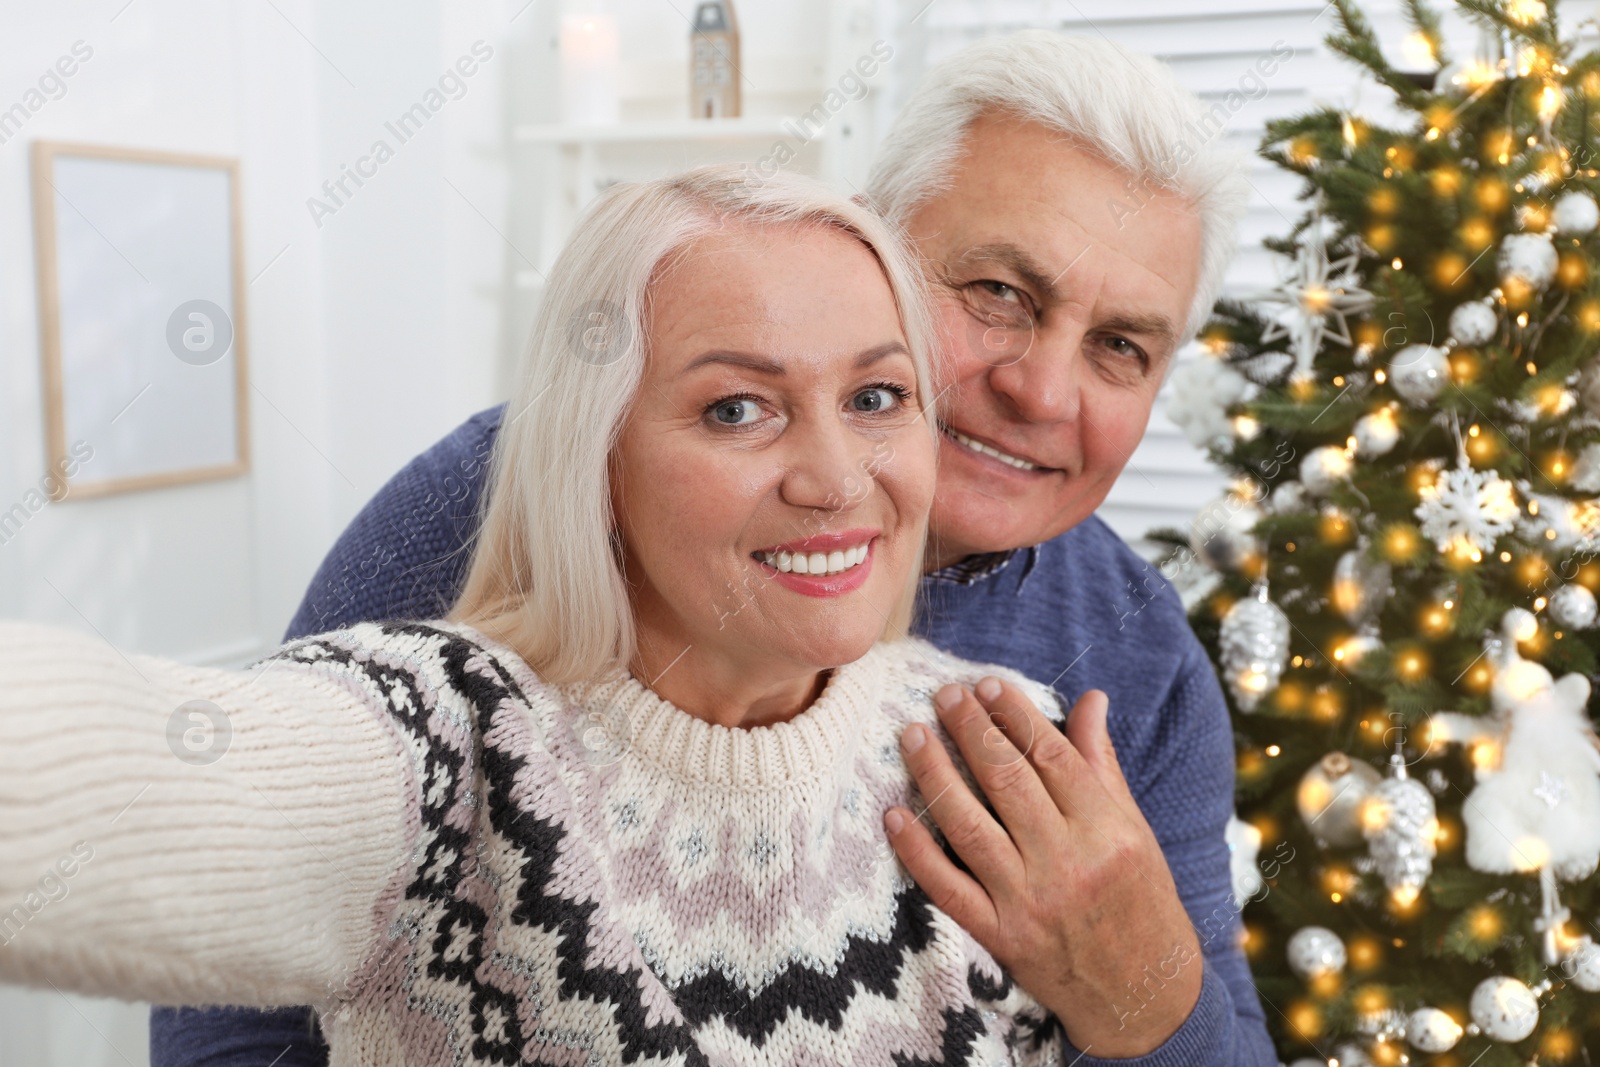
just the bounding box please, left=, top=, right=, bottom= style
left=907, top=115, right=1200, bottom=566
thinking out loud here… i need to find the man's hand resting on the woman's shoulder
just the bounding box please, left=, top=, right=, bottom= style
left=883, top=678, right=1202, bottom=1057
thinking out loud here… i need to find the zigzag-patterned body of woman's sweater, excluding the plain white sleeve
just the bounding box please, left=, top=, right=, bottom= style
left=264, top=622, right=1064, bottom=1067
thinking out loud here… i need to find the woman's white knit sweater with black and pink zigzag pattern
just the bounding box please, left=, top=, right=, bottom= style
left=0, top=622, right=1064, bottom=1067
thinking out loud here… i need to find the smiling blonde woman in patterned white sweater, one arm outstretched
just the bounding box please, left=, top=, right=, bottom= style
left=0, top=168, right=1061, bottom=1065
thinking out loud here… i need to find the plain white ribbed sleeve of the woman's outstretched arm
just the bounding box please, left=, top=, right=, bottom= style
left=0, top=622, right=414, bottom=1006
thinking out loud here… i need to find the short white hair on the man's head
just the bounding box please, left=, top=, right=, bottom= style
left=867, top=30, right=1254, bottom=341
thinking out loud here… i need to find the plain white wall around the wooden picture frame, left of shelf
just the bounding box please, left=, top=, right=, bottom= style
left=0, top=0, right=508, bottom=1067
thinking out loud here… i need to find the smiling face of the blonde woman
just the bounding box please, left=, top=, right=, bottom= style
left=613, top=224, right=936, bottom=678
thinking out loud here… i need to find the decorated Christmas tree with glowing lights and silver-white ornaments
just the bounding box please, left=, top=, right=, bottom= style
left=1154, top=0, right=1600, bottom=1067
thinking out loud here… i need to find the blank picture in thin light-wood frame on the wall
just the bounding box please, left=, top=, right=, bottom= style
left=32, top=141, right=250, bottom=498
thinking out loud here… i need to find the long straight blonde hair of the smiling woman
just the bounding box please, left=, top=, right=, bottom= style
left=448, top=165, right=936, bottom=683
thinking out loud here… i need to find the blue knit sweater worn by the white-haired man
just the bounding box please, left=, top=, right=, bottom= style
left=150, top=408, right=1278, bottom=1067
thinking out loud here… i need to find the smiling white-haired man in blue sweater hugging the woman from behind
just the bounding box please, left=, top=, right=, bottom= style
left=152, top=32, right=1277, bottom=1067
